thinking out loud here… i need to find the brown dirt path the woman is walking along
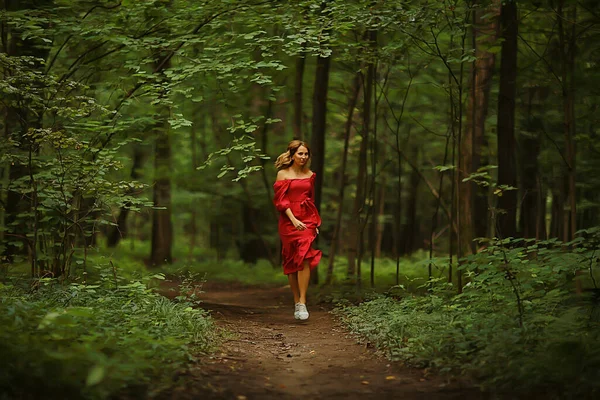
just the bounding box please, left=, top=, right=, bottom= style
left=160, top=283, right=489, bottom=400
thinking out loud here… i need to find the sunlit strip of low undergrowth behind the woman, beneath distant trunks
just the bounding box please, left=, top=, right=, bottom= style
left=77, top=239, right=438, bottom=290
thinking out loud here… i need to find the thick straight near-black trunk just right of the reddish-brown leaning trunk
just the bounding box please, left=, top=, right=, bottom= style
left=496, top=0, right=518, bottom=237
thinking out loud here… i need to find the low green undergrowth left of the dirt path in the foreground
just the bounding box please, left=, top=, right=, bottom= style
left=0, top=276, right=218, bottom=399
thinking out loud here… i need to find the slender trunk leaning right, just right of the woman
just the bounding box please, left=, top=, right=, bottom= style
left=325, top=74, right=360, bottom=285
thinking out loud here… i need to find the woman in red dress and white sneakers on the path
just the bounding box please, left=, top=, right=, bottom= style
left=273, top=140, right=321, bottom=320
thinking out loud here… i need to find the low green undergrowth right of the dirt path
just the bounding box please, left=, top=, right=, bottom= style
left=337, top=238, right=600, bottom=398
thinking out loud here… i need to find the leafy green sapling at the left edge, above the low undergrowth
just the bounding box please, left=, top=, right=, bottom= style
left=0, top=53, right=149, bottom=276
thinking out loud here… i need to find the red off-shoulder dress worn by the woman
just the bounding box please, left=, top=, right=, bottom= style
left=273, top=173, right=322, bottom=275
